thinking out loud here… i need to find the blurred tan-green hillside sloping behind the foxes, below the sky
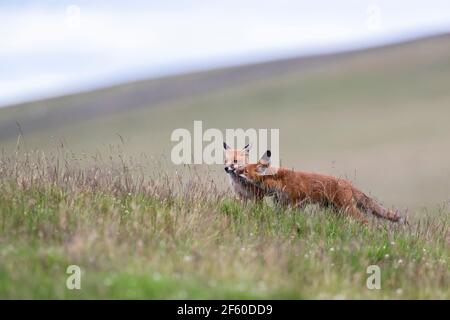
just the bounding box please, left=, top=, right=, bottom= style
left=0, top=35, right=450, bottom=208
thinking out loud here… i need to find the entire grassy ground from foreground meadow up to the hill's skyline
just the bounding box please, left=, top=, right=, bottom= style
left=0, top=35, right=450, bottom=299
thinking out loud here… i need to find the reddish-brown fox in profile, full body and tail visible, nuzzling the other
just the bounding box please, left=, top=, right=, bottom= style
left=236, top=150, right=403, bottom=223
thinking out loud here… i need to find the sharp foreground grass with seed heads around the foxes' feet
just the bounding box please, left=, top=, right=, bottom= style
left=0, top=152, right=450, bottom=299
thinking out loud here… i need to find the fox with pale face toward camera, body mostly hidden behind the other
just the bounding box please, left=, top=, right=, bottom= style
left=223, top=142, right=264, bottom=201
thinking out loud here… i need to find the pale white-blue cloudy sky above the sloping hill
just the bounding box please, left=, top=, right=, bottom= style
left=0, top=0, right=450, bottom=106
